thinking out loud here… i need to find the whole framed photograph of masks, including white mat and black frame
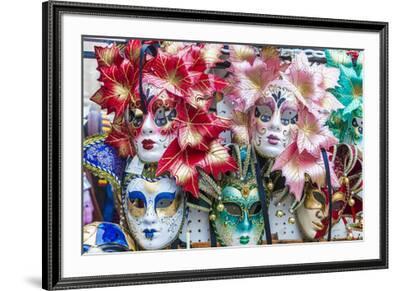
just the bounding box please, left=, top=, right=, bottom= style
left=43, top=1, right=388, bottom=290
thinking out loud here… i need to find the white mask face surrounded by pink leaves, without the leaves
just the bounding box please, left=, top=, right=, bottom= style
left=251, top=86, right=297, bottom=157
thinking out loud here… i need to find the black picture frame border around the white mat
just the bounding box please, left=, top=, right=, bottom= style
left=42, top=1, right=388, bottom=290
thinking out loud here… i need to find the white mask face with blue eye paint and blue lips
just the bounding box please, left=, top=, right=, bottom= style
left=124, top=177, right=185, bottom=250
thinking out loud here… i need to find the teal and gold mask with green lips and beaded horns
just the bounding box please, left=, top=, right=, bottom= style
left=202, top=146, right=264, bottom=246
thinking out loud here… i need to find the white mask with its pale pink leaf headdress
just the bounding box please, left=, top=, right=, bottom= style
left=228, top=46, right=342, bottom=216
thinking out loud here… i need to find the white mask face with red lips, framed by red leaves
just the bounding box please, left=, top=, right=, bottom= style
left=125, top=91, right=176, bottom=163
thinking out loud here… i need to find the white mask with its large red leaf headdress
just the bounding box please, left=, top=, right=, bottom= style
left=91, top=40, right=236, bottom=197
